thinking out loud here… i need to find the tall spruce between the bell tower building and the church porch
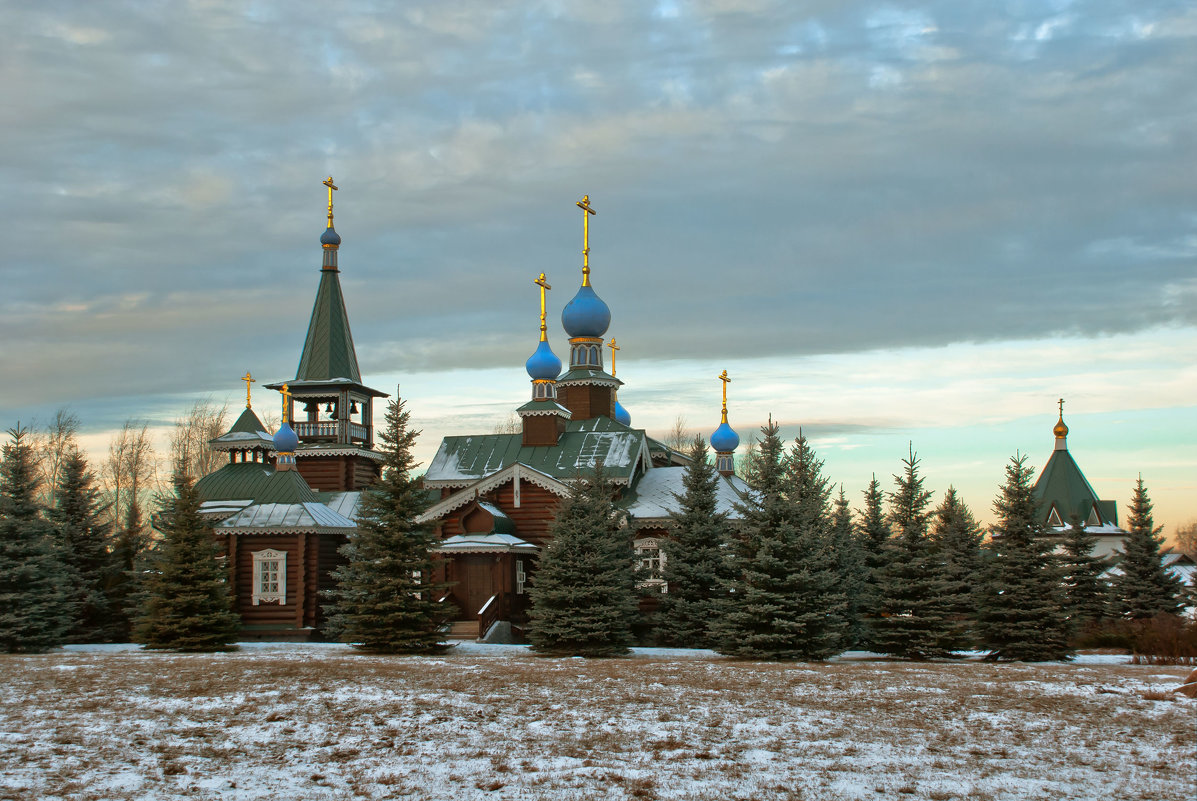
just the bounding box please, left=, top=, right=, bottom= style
left=326, top=400, right=449, bottom=654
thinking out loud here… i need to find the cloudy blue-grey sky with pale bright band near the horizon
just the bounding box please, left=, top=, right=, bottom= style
left=0, top=0, right=1197, bottom=526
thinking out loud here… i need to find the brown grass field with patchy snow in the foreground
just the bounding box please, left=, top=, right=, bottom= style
left=0, top=644, right=1197, bottom=801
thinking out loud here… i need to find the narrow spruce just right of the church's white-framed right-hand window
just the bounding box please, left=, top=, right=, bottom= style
left=657, top=437, right=730, bottom=648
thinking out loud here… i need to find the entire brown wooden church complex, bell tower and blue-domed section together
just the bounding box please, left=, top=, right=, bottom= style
left=196, top=177, right=748, bottom=641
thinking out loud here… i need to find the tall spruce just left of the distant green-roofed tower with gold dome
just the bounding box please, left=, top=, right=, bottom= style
left=977, top=455, right=1073, bottom=662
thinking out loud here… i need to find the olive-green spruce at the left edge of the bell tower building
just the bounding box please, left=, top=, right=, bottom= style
left=134, top=471, right=241, bottom=651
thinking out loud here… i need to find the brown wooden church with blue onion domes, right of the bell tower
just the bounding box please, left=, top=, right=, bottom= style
left=421, top=191, right=748, bottom=639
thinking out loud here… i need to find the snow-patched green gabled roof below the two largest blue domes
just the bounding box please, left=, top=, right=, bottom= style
left=424, top=417, right=648, bottom=487
